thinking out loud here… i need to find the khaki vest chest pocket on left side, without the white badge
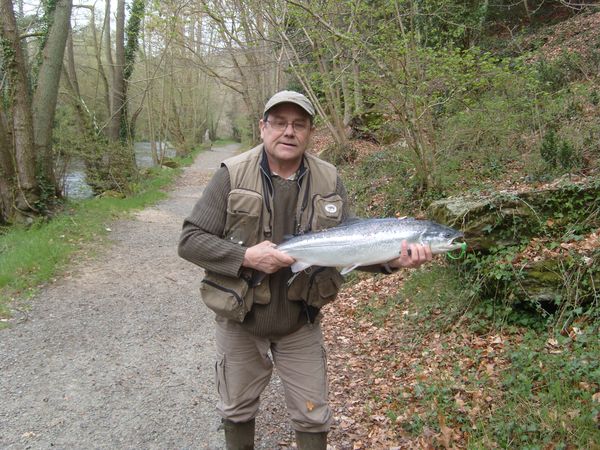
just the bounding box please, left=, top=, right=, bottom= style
left=224, top=189, right=263, bottom=247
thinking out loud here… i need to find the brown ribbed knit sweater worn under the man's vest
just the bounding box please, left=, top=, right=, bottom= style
left=179, top=167, right=349, bottom=337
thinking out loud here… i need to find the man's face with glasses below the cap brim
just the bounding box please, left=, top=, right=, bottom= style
left=259, top=103, right=312, bottom=168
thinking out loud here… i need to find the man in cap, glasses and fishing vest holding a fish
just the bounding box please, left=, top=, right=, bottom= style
left=179, top=91, right=431, bottom=450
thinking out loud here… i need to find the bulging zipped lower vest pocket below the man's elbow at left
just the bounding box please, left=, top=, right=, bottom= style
left=200, top=272, right=253, bottom=323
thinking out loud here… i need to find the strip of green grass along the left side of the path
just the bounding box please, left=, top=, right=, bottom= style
left=0, top=151, right=204, bottom=328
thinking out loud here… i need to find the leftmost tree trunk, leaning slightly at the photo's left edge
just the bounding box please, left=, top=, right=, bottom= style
left=0, top=0, right=39, bottom=214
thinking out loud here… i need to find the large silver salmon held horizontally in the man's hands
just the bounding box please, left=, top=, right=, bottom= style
left=277, top=217, right=464, bottom=275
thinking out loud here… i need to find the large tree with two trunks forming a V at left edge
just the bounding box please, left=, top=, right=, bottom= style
left=0, top=0, right=72, bottom=221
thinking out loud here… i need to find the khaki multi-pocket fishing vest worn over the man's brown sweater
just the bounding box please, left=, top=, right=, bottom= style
left=201, top=144, right=344, bottom=322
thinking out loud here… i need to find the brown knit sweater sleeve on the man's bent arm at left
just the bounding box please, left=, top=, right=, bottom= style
left=178, top=167, right=246, bottom=277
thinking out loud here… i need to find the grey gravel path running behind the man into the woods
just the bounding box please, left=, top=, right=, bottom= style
left=0, top=145, right=291, bottom=450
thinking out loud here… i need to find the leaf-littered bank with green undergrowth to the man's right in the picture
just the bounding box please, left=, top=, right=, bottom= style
left=315, top=13, right=600, bottom=449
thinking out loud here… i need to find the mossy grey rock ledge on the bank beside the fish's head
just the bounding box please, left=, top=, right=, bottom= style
left=428, top=180, right=600, bottom=306
